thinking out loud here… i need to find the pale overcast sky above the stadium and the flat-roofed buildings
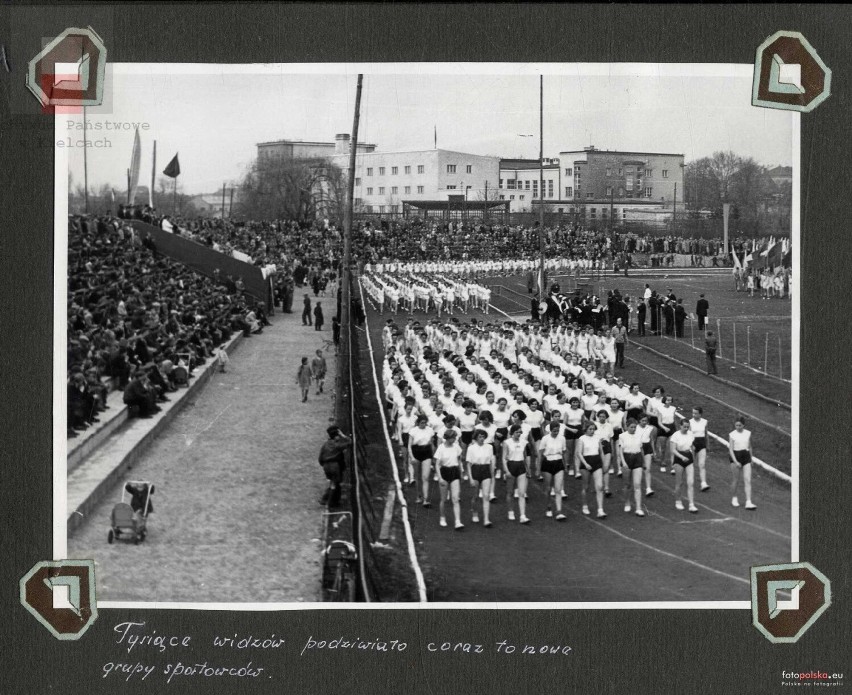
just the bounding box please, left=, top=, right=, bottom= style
left=66, top=64, right=793, bottom=193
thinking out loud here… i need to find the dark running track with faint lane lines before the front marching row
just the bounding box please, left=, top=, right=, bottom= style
left=368, top=296, right=792, bottom=602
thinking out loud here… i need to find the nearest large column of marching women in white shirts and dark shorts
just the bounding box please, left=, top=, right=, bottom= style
left=382, top=318, right=756, bottom=529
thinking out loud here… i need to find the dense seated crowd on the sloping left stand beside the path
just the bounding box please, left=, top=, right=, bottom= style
left=67, top=216, right=262, bottom=437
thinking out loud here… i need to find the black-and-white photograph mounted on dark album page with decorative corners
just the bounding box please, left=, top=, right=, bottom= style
left=61, top=63, right=801, bottom=611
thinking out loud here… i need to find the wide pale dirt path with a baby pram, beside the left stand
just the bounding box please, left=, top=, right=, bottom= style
left=68, top=314, right=335, bottom=602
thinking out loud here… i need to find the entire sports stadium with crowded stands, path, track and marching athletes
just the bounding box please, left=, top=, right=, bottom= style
left=56, top=69, right=798, bottom=606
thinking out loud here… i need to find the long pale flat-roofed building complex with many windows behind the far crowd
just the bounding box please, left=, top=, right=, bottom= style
left=257, top=133, right=684, bottom=222
